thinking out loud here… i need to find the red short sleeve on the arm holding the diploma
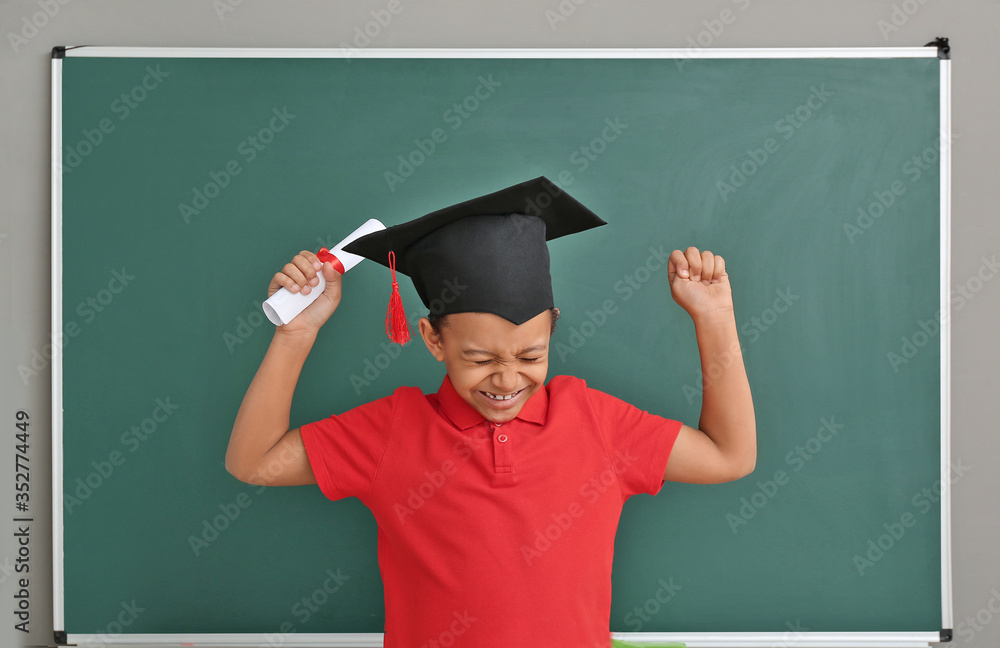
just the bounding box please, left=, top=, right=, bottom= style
left=299, top=392, right=398, bottom=501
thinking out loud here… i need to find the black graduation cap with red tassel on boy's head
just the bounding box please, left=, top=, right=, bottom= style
left=344, top=176, right=607, bottom=344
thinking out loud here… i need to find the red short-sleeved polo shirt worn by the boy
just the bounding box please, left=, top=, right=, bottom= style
left=301, top=376, right=681, bottom=648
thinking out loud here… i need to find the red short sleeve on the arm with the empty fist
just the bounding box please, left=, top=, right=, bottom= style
left=587, top=387, right=681, bottom=499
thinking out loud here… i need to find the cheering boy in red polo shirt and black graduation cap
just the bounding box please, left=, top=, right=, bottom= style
left=226, top=178, right=756, bottom=648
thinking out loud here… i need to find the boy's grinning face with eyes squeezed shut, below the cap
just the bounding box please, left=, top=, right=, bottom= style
left=420, top=310, right=552, bottom=423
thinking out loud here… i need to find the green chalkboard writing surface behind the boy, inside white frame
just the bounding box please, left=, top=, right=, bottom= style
left=54, top=53, right=942, bottom=634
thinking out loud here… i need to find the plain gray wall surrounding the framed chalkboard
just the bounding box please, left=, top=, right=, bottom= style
left=0, top=0, right=1000, bottom=648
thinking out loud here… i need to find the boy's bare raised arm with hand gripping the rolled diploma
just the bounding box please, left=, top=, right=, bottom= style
left=226, top=250, right=341, bottom=486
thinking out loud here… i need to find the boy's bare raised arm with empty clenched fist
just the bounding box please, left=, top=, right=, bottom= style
left=663, top=247, right=757, bottom=484
